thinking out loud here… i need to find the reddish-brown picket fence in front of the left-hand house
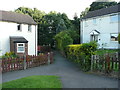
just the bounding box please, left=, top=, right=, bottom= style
left=1, top=52, right=53, bottom=72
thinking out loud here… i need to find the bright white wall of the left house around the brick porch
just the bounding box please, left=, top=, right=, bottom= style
left=0, top=21, right=37, bottom=55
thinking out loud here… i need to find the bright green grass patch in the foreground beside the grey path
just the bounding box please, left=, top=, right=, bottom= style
left=2, top=76, right=62, bottom=88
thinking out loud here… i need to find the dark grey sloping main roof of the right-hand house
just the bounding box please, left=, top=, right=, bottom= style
left=82, top=4, right=120, bottom=19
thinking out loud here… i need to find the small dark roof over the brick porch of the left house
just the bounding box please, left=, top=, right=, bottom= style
left=10, top=36, right=28, bottom=43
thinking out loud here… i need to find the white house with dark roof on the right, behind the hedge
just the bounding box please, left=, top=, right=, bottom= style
left=80, top=4, right=120, bottom=49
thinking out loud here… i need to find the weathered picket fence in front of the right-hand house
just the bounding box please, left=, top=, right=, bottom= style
left=91, top=53, right=120, bottom=73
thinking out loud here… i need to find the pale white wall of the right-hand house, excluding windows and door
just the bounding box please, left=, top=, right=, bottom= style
left=81, top=14, right=118, bottom=49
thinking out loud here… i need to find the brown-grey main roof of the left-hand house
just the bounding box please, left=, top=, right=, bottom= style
left=0, top=10, right=37, bottom=25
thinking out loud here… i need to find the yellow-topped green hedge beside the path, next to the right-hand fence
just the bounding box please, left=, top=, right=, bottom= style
left=66, top=42, right=97, bottom=71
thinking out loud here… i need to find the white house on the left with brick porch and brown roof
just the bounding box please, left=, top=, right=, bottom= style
left=0, top=11, right=37, bottom=56
